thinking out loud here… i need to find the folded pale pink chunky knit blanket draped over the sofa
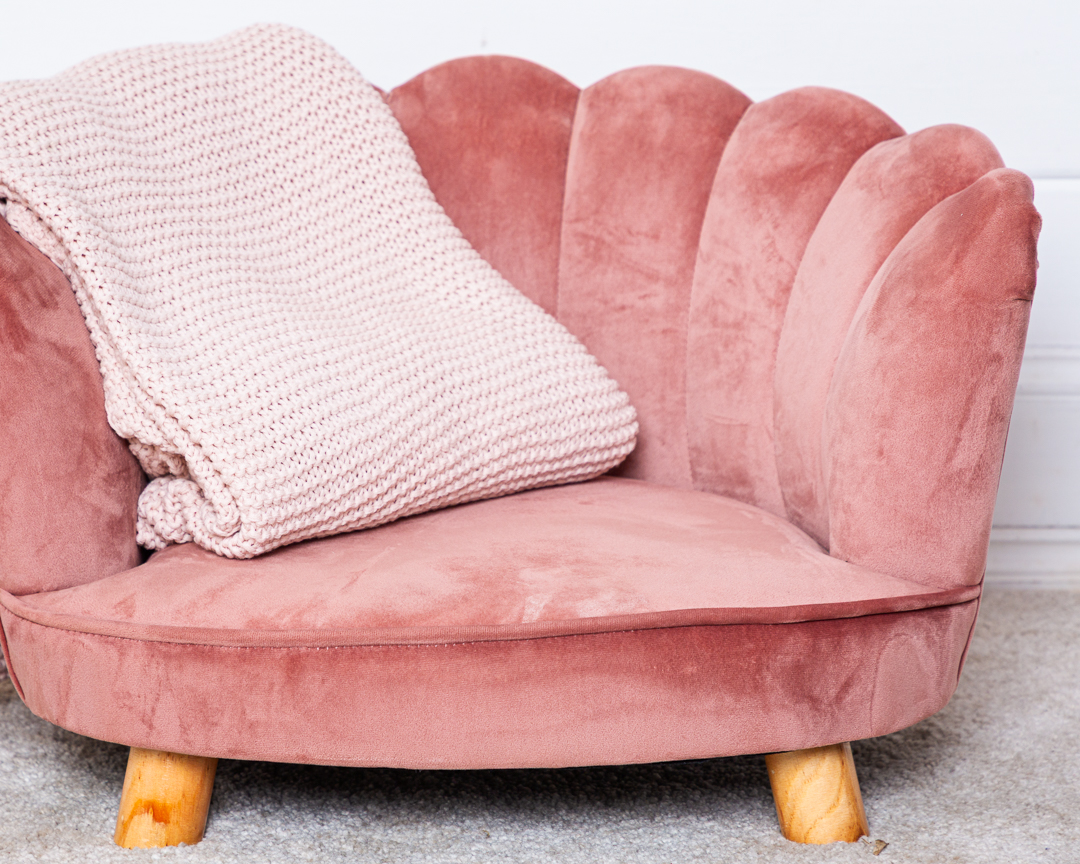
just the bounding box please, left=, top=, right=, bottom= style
left=0, top=25, right=637, bottom=557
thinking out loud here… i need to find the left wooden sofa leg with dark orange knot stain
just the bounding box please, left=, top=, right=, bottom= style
left=113, top=747, right=217, bottom=849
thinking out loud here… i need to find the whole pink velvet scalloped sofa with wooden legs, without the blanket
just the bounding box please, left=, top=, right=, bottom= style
left=0, top=56, right=1039, bottom=845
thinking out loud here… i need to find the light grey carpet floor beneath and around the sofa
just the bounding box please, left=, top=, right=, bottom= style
left=0, top=588, right=1080, bottom=864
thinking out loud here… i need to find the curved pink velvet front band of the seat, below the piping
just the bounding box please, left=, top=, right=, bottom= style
left=0, top=597, right=976, bottom=768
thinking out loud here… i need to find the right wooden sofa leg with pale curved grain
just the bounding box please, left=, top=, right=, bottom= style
left=765, top=743, right=869, bottom=843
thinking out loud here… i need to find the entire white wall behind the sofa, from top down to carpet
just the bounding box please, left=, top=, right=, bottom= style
left=6, top=0, right=1080, bottom=586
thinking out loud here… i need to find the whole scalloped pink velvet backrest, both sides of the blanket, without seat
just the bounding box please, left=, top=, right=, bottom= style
left=0, top=56, right=1039, bottom=593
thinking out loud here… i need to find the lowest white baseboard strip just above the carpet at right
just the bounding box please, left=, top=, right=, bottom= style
left=986, top=528, right=1080, bottom=591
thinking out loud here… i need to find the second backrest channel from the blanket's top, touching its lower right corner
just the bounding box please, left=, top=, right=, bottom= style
left=557, top=67, right=750, bottom=486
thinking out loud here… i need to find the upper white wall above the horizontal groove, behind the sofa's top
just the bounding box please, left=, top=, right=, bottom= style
left=0, top=0, right=1080, bottom=177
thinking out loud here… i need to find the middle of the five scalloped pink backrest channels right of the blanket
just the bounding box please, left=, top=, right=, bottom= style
left=687, top=87, right=903, bottom=515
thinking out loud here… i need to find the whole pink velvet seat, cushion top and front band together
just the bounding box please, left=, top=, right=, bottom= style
left=0, top=477, right=978, bottom=768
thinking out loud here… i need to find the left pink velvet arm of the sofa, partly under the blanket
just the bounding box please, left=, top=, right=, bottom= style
left=0, top=219, right=146, bottom=594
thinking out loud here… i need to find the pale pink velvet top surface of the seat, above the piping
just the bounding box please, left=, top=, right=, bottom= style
left=8, top=477, right=954, bottom=644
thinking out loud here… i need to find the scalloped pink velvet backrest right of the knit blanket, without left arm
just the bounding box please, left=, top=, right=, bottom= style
left=390, top=57, right=1038, bottom=586
